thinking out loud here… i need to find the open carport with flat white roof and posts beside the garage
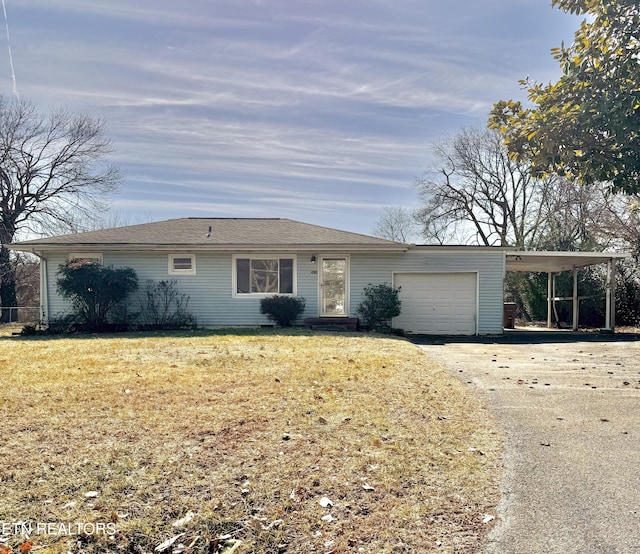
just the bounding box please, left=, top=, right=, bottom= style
left=505, top=250, right=629, bottom=332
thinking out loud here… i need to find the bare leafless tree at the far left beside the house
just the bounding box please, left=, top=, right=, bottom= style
left=0, top=96, right=120, bottom=320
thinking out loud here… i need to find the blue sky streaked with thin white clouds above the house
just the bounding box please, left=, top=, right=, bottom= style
left=0, top=0, right=580, bottom=233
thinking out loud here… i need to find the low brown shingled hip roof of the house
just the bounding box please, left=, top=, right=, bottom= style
left=8, top=217, right=408, bottom=251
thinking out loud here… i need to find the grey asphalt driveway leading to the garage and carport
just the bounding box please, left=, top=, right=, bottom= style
left=417, top=334, right=640, bottom=554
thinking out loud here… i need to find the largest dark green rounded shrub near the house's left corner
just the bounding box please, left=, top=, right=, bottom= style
left=57, top=261, right=138, bottom=331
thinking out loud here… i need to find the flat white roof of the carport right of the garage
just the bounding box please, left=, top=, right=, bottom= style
left=506, top=250, right=630, bottom=273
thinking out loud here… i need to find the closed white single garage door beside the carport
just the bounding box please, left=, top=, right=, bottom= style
left=393, top=273, right=476, bottom=335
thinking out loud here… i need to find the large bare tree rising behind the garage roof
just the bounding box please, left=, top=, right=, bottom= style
left=417, top=129, right=557, bottom=248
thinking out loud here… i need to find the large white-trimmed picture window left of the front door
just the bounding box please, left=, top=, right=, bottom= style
left=233, top=256, right=295, bottom=296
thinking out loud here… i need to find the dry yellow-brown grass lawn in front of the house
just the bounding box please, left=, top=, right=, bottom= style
left=0, top=331, right=501, bottom=554
